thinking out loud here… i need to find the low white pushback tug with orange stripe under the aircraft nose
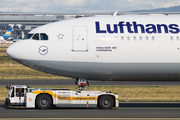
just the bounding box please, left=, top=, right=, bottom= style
left=4, top=85, right=119, bottom=109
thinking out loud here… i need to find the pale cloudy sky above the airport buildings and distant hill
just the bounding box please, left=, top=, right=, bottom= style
left=0, top=0, right=180, bottom=12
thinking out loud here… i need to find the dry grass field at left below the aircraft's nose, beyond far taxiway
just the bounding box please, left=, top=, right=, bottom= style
left=0, top=45, right=69, bottom=79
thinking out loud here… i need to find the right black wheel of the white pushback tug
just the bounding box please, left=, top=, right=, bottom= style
left=99, top=95, right=114, bottom=109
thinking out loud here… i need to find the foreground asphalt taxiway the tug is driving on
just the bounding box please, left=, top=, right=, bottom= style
left=0, top=103, right=180, bottom=120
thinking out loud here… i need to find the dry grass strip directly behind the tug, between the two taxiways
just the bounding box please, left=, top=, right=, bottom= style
left=0, top=86, right=180, bottom=102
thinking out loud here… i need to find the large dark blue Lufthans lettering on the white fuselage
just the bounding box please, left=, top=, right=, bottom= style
left=95, top=21, right=180, bottom=34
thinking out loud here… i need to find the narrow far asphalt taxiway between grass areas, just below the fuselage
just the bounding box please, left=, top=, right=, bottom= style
left=0, top=79, right=180, bottom=86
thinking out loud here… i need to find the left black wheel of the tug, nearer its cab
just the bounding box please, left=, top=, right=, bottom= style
left=36, top=94, right=52, bottom=109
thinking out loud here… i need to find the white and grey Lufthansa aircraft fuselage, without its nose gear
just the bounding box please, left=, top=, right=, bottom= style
left=7, top=13, right=180, bottom=85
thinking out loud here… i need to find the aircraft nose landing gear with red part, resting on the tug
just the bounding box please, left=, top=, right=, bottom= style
left=74, top=78, right=89, bottom=91
